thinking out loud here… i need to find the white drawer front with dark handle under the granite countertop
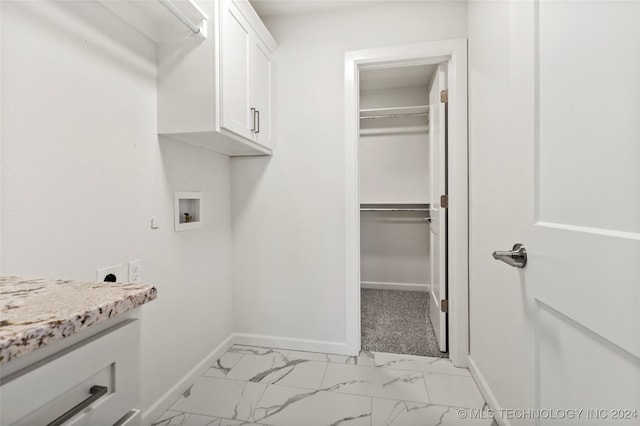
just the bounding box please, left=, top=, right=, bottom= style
left=0, top=320, right=140, bottom=426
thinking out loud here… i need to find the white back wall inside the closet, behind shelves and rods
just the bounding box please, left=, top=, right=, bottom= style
left=358, top=86, right=431, bottom=285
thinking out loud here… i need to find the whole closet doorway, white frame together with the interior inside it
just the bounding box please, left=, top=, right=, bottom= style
left=345, top=40, right=469, bottom=366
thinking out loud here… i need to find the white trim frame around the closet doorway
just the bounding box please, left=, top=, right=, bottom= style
left=345, top=39, right=469, bottom=367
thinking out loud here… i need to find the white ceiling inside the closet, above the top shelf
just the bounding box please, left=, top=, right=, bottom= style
left=360, top=64, right=438, bottom=90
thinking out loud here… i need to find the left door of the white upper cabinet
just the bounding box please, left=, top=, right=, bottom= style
left=220, top=0, right=253, bottom=139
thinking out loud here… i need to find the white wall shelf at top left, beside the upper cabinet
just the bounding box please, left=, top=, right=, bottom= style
left=98, top=0, right=208, bottom=43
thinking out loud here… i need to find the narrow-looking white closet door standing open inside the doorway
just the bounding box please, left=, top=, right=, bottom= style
left=429, top=65, right=447, bottom=352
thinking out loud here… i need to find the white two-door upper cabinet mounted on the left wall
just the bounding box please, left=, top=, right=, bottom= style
left=150, top=0, right=276, bottom=156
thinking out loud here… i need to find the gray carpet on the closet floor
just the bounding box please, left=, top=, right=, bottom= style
left=360, top=288, right=448, bottom=358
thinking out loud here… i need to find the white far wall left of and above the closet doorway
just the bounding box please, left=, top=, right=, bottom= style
left=232, top=2, right=466, bottom=349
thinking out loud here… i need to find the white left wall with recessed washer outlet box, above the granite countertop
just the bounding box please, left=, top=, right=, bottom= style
left=1, top=2, right=232, bottom=416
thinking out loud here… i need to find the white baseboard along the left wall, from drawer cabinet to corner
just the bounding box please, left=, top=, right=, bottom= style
left=141, top=334, right=234, bottom=426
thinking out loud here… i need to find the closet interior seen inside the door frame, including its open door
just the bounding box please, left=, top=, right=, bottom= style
left=358, top=64, right=447, bottom=357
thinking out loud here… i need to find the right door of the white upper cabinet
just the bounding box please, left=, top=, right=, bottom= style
left=251, top=37, right=271, bottom=147
